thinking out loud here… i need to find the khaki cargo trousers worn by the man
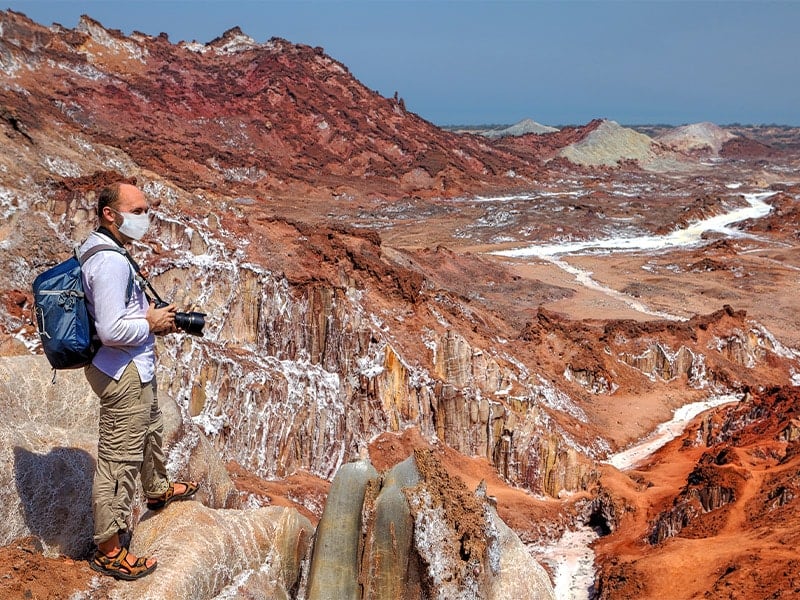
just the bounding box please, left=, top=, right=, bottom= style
left=84, top=362, right=169, bottom=544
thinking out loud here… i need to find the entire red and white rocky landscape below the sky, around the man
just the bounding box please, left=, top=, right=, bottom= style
left=0, top=11, right=800, bottom=599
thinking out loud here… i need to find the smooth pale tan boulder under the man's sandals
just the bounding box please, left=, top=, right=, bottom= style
left=108, top=501, right=314, bottom=600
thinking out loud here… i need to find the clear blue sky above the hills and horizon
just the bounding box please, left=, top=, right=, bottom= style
left=6, top=0, right=800, bottom=125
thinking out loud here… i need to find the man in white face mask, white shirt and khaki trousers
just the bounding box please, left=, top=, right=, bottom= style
left=79, top=183, right=198, bottom=580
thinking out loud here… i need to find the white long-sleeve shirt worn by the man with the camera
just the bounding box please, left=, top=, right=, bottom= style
left=79, top=231, right=155, bottom=383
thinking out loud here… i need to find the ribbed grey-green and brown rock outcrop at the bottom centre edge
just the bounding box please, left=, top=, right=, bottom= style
left=306, top=450, right=555, bottom=600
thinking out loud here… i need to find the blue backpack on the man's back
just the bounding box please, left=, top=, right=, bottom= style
left=33, top=244, right=133, bottom=369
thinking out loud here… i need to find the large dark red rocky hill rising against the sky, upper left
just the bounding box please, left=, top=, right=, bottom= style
left=0, top=11, right=552, bottom=203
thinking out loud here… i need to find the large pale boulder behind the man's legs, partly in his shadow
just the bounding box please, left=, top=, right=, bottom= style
left=0, top=355, right=238, bottom=558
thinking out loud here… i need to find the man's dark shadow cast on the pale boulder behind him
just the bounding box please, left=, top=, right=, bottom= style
left=14, top=446, right=95, bottom=559
